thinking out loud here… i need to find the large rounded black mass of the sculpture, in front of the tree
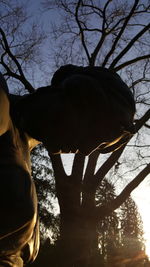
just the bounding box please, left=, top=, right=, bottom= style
left=18, top=65, right=135, bottom=155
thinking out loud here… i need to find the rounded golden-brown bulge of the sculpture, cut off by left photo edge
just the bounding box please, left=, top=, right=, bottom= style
left=0, top=73, right=10, bottom=135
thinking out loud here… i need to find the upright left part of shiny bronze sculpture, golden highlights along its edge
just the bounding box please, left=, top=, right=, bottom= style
left=0, top=74, right=39, bottom=267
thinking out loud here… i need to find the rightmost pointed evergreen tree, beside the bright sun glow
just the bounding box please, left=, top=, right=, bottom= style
left=120, top=197, right=146, bottom=266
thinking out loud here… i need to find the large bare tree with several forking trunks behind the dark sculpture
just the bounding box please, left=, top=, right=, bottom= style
left=1, top=0, right=150, bottom=267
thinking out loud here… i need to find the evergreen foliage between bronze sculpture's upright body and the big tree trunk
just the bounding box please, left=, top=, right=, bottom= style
left=31, top=145, right=59, bottom=241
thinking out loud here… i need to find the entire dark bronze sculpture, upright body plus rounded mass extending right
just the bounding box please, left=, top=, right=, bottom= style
left=0, top=65, right=135, bottom=267
